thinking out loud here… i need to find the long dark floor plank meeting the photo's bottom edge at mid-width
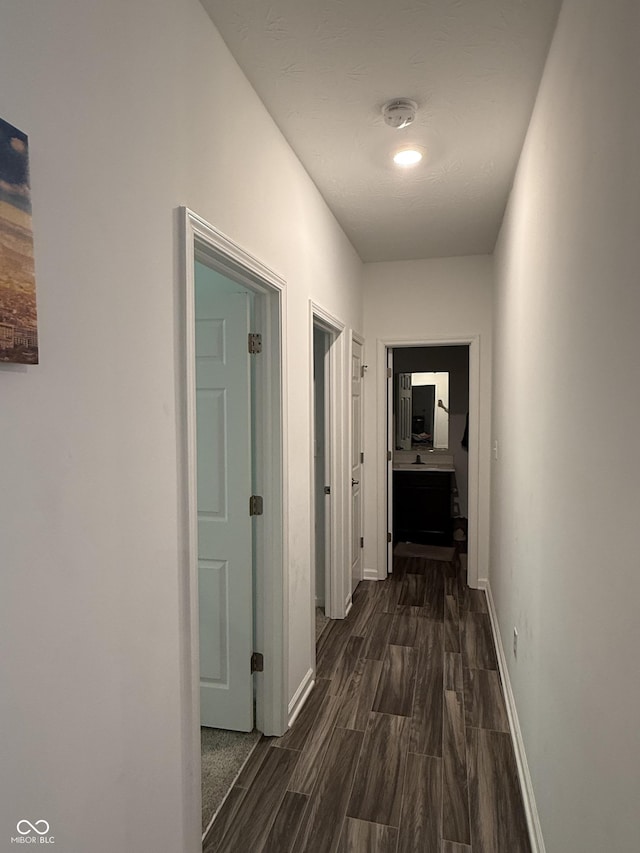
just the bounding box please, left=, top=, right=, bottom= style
left=293, top=729, right=364, bottom=853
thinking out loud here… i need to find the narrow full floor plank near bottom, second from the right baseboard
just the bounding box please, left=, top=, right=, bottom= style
left=442, top=690, right=471, bottom=844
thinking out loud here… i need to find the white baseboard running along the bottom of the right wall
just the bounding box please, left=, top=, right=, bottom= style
left=478, top=578, right=546, bottom=853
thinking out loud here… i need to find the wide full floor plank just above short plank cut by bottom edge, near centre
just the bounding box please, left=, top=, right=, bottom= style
left=347, top=713, right=409, bottom=826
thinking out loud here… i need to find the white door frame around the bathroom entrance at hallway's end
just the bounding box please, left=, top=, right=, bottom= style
left=377, top=335, right=480, bottom=588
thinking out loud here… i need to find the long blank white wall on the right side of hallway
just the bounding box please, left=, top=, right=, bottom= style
left=491, top=0, right=640, bottom=853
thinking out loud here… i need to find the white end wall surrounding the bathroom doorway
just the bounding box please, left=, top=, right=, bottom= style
left=364, top=255, right=493, bottom=578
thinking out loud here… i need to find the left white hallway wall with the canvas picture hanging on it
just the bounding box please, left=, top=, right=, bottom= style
left=0, top=0, right=362, bottom=853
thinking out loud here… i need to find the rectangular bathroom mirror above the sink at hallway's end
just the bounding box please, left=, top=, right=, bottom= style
left=394, top=373, right=449, bottom=450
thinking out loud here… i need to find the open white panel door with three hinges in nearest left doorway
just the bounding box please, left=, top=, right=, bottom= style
left=196, top=282, right=253, bottom=731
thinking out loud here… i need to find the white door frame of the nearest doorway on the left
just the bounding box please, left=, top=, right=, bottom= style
left=176, top=207, right=288, bottom=853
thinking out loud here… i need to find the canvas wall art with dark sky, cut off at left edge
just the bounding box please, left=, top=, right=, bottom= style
left=0, top=119, right=38, bottom=364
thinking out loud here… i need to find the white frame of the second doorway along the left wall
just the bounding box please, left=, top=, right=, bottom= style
left=309, top=299, right=347, bottom=628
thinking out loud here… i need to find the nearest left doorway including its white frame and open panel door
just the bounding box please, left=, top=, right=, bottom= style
left=178, top=208, right=287, bottom=850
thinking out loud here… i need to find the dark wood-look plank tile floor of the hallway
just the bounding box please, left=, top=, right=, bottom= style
left=203, top=557, right=531, bottom=853
